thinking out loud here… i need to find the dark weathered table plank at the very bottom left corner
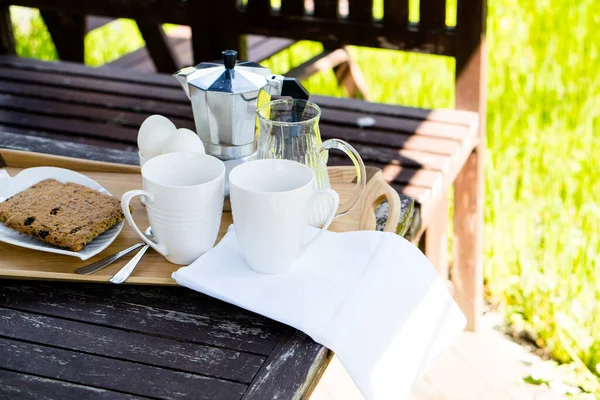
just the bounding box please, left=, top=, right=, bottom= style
left=0, top=368, right=140, bottom=400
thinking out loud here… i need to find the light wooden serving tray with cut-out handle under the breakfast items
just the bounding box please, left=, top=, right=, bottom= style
left=0, top=149, right=401, bottom=285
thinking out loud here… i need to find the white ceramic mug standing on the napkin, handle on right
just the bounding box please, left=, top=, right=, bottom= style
left=229, top=159, right=340, bottom=274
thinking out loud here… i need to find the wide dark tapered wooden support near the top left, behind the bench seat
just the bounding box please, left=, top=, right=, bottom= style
left=40, top=10, right=86, bottom=63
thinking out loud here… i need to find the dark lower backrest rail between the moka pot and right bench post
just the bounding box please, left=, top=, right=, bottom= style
left=234, top=0, right=464, bottom=57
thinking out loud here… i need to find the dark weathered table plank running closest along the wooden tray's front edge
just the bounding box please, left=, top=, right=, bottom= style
left=0, top=283, right=279, bottom=355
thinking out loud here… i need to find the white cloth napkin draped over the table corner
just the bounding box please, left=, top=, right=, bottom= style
left=173, top=225, right=465, bottom=399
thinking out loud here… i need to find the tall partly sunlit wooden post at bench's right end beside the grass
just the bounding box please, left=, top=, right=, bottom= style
left=451, top=0, right=487, bottom=331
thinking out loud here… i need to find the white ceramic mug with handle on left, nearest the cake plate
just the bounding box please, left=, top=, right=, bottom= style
left=121, top=153, right=225, bottom=265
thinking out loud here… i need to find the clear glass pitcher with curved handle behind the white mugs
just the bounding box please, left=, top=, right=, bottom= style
left=256, top=99, right=367, bottom=227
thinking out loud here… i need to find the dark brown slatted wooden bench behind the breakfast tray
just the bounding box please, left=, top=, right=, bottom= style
left=0, top=0, right=486, bottom=329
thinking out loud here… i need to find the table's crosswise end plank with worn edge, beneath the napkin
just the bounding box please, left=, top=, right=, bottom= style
left=242, top=328, right=333, bottom=400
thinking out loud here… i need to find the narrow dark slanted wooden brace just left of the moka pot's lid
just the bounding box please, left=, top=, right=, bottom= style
left=135, top=20, right=179, bottom=74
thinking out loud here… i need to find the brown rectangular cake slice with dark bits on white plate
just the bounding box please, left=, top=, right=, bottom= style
left=0, top=179, right=123, bottom=251
